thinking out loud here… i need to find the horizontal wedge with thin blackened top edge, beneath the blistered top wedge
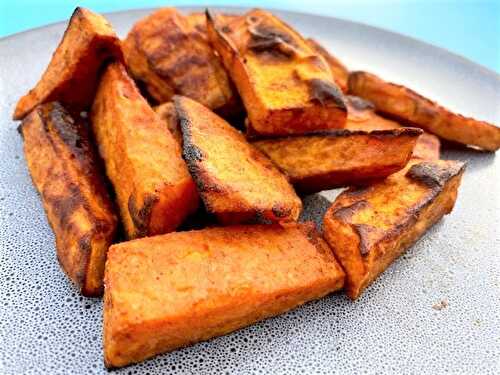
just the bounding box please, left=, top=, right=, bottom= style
left=253, top=128, right=422, bottom=193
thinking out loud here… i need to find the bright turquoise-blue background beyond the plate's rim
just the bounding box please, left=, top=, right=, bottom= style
left=0, top=0, right=500, bottom=72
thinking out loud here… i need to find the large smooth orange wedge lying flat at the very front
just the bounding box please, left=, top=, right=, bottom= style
left=104, top=223, right=344, bottom=367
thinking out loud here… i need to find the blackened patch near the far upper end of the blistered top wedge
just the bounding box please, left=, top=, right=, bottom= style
left=248, top=21, right=298, bottom=59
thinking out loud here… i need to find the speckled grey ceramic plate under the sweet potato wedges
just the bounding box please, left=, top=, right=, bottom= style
left=0, top=9, right=500, bottom=374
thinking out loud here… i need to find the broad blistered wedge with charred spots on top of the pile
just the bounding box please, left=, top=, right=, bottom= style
left=207, top=9, right=347, bottom=135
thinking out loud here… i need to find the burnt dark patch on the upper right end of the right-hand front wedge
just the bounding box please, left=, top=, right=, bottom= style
left=406, top=162, right=465, bottom=188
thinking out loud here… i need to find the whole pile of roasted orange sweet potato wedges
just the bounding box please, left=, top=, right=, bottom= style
left=13, top=8, right=500, bottom=367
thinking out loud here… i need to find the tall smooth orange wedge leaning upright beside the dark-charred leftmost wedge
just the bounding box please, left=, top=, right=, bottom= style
left=91, top=63, right=199, bottom=238
